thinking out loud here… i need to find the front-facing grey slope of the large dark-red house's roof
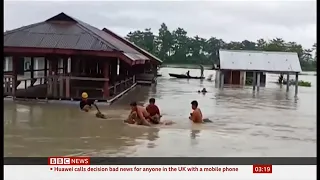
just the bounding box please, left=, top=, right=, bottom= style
left=3, top=22, right=114, bottom=51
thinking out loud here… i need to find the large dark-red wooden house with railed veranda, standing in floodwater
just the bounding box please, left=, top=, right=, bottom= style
left=3, top=13, right=162, bottom=102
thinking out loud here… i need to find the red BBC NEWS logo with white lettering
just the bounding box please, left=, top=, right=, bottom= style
left=48, top=157, right=90, bottom=165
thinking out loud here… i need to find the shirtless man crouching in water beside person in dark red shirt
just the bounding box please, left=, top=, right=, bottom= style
left=124, top=102, right=151, bottom=126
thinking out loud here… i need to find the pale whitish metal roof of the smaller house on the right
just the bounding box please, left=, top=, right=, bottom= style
left=219, top=50, right=302, bottom=72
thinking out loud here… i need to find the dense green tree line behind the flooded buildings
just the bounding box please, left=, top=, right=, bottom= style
left=126, top=23, right=317, bottom=71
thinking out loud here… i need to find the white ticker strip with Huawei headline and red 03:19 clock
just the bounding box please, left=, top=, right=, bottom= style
left=4, top=164, right=317, bottom=180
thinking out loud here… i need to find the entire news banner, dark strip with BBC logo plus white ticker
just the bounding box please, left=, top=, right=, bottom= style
left=4, top=157, right=317, bottom=180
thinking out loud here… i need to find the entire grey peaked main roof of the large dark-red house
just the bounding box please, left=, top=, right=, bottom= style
left=3, top=13, right=148, bottom=60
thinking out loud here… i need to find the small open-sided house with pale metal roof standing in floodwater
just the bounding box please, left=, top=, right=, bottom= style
left=216, top=50, right=301, bottom=95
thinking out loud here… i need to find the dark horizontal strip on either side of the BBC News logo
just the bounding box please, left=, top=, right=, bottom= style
left=4, top=157, right=317, bottom=165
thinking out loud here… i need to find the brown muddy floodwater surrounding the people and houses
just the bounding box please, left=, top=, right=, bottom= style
left=4, top=68, right=316, bottom=157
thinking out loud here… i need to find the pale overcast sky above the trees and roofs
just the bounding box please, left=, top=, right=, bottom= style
left=4, top=0, right=316, bottom=48
